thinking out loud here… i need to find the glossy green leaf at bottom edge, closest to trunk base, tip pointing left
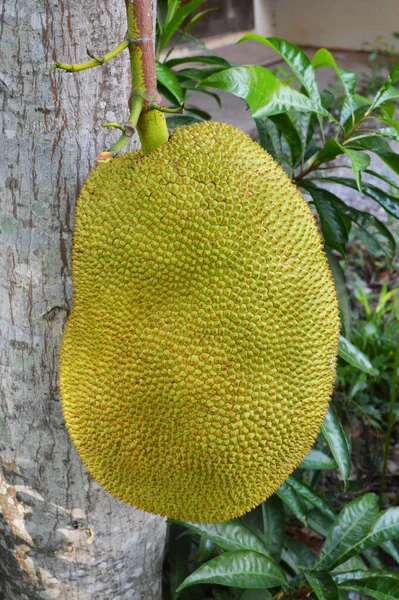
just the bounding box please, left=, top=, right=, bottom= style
left=177, top=550, right=287, bottom=592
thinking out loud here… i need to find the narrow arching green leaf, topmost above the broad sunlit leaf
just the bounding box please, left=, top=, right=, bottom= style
left=238, top=33, right=320, bottom=104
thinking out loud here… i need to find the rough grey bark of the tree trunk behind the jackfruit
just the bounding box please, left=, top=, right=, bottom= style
left=0, top=0, right=165, bottom=600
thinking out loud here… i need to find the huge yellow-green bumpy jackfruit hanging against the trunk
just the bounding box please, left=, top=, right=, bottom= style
left=61, top=123, right=338, bottom=522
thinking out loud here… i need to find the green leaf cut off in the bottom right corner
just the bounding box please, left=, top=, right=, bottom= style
left=339, top=571, right=399, bottom=600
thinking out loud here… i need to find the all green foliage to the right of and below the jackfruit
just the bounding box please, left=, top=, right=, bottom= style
left=159, top=27, right=399, bottom=600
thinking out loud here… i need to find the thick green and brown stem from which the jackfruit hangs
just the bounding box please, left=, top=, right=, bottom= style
left=125, top=0, right=169, bottom=155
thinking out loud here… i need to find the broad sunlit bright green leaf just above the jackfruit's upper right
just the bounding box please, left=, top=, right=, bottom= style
left=201, top=65, right=333, bottom=120
